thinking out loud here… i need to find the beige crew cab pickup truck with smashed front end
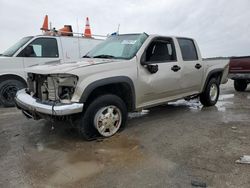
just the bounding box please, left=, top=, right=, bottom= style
left=15, top=33, right=229, bottom=139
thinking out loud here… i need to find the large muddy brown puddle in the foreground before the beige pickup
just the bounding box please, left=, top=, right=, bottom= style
left=21, top=135, right=144, bottom=187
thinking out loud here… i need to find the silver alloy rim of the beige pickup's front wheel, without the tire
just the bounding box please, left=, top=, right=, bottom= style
left=94, top=105, right=122, bottom=137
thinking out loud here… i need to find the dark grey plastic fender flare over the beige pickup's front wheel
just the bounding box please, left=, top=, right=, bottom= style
left=80, top=76, right=135, bottom=110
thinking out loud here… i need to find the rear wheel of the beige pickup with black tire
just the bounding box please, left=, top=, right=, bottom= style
left=200, top=78, right=220, bottom=106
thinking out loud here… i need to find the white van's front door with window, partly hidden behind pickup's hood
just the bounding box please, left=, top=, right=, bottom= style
left=18, top=37, right=60, bottom=68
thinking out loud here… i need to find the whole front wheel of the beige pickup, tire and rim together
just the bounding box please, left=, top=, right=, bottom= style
left=79, top=94, right=127, bottom=140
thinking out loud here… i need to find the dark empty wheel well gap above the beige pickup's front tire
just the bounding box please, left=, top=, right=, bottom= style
left=84, top=83, right=134, bottom=111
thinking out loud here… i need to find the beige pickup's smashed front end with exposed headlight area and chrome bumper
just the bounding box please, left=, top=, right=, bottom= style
left=15, top=73, right=83, bottom=119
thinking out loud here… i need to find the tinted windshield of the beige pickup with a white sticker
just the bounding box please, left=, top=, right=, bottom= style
left=84, top=33, right=148, bottom=59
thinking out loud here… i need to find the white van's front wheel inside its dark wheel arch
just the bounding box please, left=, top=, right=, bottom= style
left=0, top=79, right=26, bottom=107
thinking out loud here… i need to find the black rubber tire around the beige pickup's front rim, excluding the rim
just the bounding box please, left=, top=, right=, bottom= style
left=79, top=94, right=128, bottom=140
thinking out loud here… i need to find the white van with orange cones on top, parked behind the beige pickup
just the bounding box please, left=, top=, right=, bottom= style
left=0, top=35, right=103, bottom=107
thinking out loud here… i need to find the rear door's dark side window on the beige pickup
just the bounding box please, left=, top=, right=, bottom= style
left=178, top=38, right=198, bottom=61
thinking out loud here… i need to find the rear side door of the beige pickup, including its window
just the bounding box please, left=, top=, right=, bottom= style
left=177, top=38, right=204, bottom=95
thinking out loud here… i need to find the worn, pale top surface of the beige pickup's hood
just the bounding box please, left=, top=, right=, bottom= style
left=25, top=58, right=118, bottom=74
